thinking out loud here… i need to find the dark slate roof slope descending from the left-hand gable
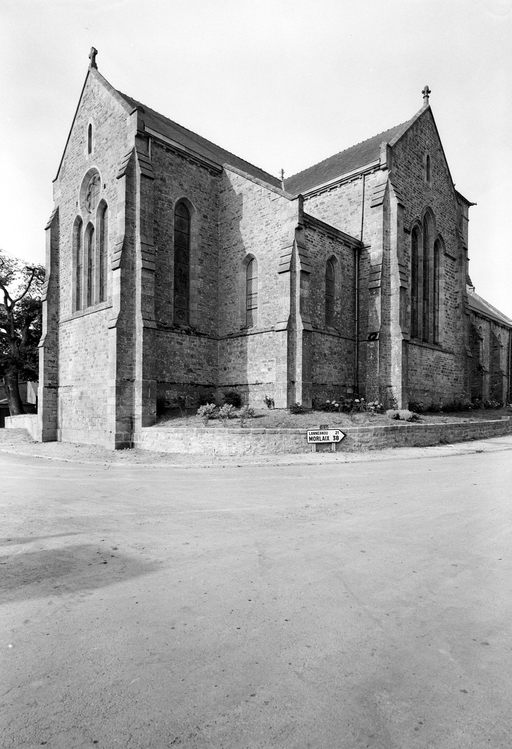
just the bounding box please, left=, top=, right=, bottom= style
left=117, top=91, right=281, bottom=189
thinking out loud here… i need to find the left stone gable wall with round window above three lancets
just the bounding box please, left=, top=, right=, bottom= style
left=46, top=71, right=136, bottom=443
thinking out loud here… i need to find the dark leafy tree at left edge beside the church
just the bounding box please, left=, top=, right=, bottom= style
left=0, top=250, right=45, bottom=416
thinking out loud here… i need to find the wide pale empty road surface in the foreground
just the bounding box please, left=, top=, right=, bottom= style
left=0, top=450, right=512, bottom=749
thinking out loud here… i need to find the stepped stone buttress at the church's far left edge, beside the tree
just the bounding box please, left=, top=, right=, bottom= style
left=37, top=208, right=60, bottom=442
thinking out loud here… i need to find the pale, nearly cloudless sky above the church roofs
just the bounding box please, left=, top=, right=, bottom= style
left=0, top=0, right=512, bottom=318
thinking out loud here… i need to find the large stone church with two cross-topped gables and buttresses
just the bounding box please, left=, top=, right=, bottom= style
left=39, top=54, right=512, bottom=448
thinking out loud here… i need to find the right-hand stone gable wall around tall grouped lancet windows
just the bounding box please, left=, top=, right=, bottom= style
left=392, top=110, right=469, bottom=403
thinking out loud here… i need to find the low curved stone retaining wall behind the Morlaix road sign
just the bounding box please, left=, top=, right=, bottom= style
left=134, top=417, right=512, bottom=455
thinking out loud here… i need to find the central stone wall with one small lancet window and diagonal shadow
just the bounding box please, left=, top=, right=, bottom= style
left=218, top=166, right=299, bottom=407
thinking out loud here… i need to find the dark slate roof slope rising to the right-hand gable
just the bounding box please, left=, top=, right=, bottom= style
left=284, top=120, right=411, bottom=195
